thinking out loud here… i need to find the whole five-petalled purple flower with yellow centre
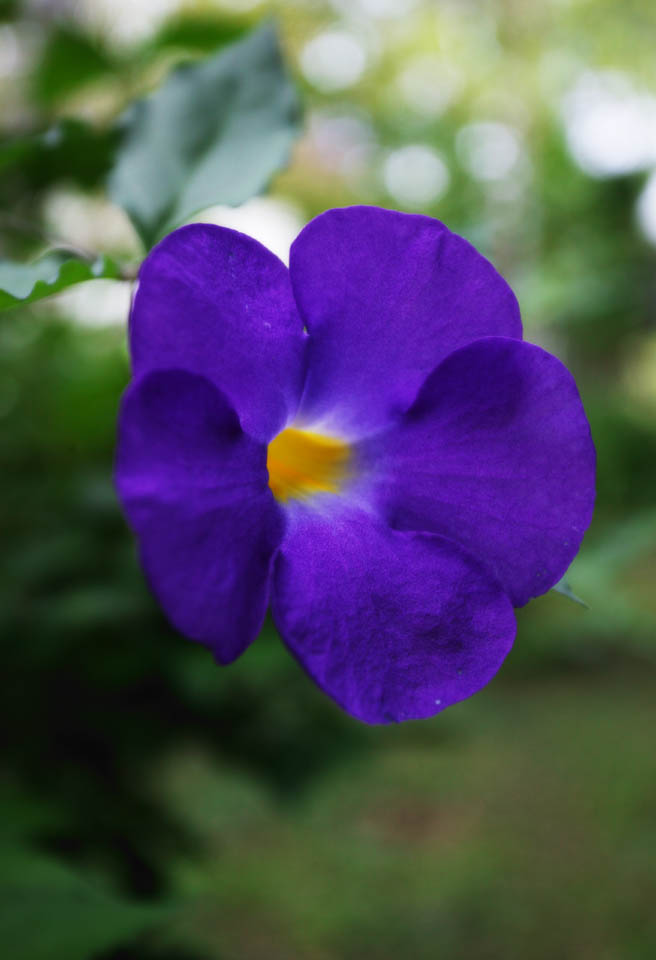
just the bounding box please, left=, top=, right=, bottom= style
left=117, top=207, right=595, bottom=723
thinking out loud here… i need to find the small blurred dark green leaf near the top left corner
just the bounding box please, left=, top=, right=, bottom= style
left=32, top=24, right=116, bottom=106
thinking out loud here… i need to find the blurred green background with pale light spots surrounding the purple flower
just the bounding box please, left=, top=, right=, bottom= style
left=0, top=0, right=656, bottom=960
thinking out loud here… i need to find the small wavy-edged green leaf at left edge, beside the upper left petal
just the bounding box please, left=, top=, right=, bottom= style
left=0, top=250, right=119, bottom=310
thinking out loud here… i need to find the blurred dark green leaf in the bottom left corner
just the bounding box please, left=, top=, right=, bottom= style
left=0, top=846, right=170, bottom=960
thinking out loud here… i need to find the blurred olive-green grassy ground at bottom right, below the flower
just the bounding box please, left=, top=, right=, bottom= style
left=162, top=671, right=656, bottom=960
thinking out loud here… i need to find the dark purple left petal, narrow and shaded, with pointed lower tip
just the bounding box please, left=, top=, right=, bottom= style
left=116, top=370, right=284, bottom=663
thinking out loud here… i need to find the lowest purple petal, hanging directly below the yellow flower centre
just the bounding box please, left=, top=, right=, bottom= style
left=272, top=498, right=515, bottom=723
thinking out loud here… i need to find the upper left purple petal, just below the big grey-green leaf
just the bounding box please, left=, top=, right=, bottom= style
left=130, top=224, right=307, bottom=441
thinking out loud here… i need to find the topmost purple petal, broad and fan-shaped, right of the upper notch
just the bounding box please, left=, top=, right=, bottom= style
left=290, top=207, right=522, bottom=439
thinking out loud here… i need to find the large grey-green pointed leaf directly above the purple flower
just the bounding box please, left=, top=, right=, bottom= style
left=109, top=26, right=299, bottom=247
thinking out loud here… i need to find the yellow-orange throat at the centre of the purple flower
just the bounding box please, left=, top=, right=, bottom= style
left=267, top=427, right=351, bottom=501
